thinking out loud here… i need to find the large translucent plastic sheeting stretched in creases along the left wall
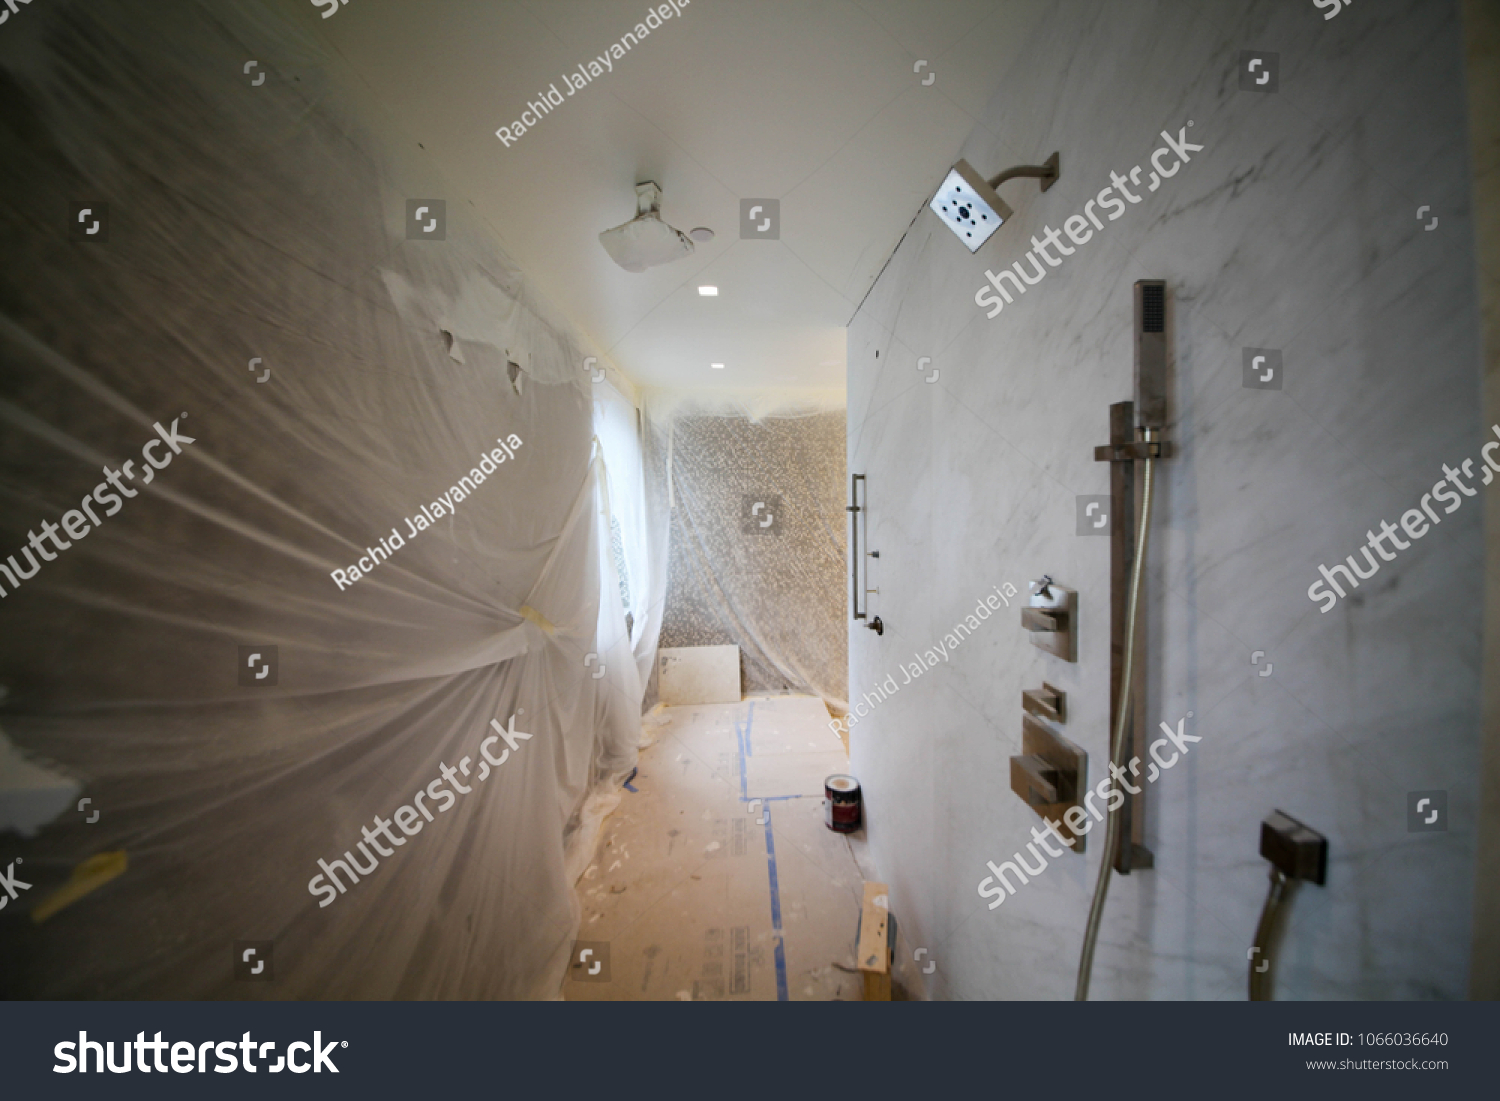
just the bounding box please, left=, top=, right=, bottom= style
left=0, top=0, right=654, bottom=998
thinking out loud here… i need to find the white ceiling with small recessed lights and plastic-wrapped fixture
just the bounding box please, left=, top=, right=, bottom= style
left=321, top=0, right=1044, bottom=390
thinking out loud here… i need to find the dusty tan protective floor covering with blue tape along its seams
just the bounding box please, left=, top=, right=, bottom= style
left=563, top=696, right=864, bottom=1002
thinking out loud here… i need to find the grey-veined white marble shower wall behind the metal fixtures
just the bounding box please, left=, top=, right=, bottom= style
left=849, top=0, right=1482, bottom=999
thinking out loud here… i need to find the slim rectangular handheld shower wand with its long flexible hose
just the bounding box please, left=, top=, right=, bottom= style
left=1073, top=279, right=1167, bottom=1002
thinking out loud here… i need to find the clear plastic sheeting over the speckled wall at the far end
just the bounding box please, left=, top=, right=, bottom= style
left=644, top=392, right=849, bottom=711
